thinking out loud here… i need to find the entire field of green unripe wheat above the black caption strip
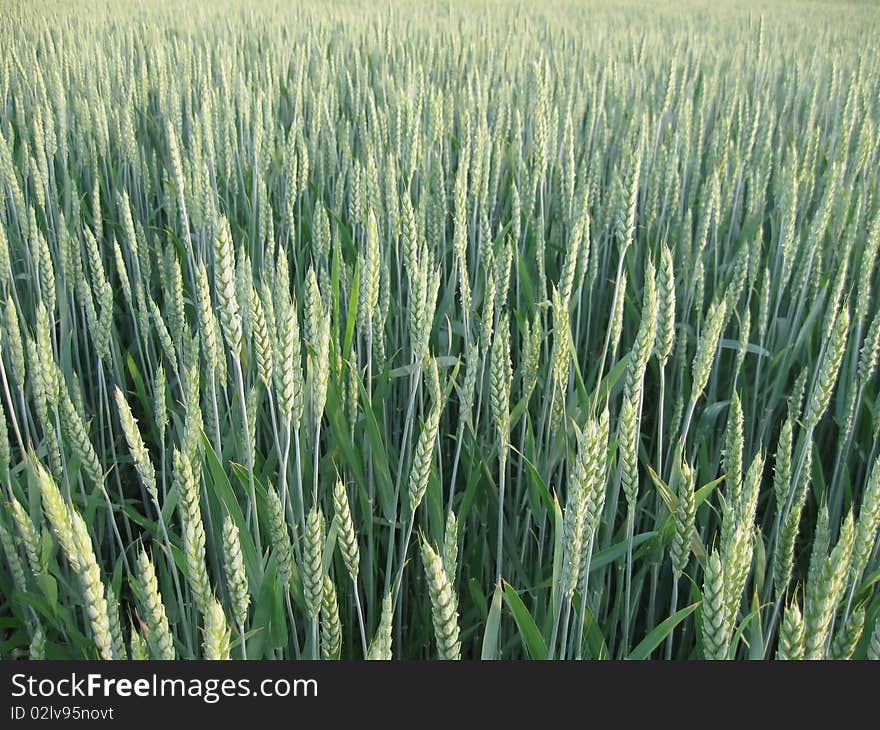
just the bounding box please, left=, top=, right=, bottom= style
left=0, top=0, right=880, bottom=659
